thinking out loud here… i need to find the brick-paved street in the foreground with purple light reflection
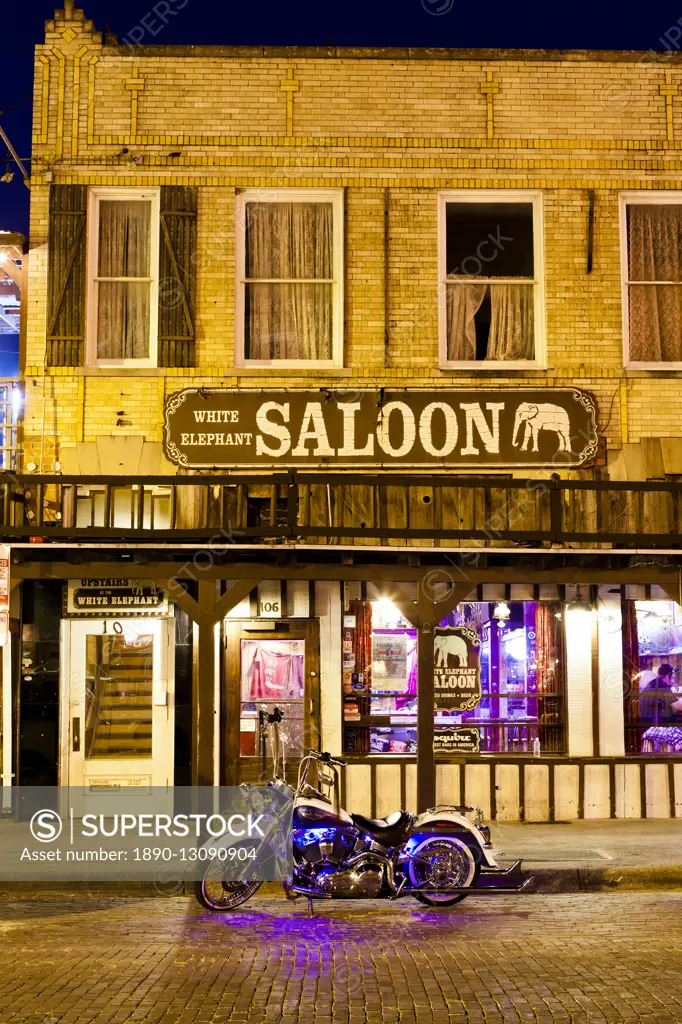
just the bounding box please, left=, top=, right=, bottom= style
left=0, top=893, right=682, bottom=1024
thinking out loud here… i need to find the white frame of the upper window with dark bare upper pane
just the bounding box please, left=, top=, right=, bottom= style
left=438, top=188, right=547, bottom=374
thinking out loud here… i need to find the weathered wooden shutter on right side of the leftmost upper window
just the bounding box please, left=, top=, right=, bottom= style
left=159, top=185, right=197, bottom=367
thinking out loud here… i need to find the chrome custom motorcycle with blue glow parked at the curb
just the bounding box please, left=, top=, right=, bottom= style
left=196, top=709, right=531, bottom=916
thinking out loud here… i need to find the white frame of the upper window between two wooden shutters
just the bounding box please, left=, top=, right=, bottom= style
left=85, top=187, right=161, bottom=368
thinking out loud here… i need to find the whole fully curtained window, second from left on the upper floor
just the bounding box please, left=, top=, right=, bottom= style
left=236, top=188, right=343, bottom=367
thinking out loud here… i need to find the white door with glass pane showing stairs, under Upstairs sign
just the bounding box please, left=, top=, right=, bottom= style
left=62, top=618, right=174, bottom=788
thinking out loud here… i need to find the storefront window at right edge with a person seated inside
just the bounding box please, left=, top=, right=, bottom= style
left=623, top=601, right=682, bottom=754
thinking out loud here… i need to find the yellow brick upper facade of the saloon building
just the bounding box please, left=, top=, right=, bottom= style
left=24, top=4, right=682, bottom=472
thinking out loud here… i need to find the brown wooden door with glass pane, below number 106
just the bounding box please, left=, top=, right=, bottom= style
left=222, top=620, right=319, bottom=785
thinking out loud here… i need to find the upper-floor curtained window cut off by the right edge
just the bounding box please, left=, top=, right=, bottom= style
left=621, top=193, right=682, bottom=370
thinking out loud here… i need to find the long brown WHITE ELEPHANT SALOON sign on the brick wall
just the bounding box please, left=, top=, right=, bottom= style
left=164, top=387, right=598, bottom=469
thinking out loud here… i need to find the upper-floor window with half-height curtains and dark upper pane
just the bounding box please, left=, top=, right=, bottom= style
left=438, top=190, right=545, bottom=370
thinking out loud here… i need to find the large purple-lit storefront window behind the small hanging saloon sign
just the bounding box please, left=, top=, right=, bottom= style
left=342, top=600, right=565, bottom=754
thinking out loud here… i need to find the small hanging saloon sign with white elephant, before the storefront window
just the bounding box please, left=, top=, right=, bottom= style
left=433, top=626, right=482, bottom=711
